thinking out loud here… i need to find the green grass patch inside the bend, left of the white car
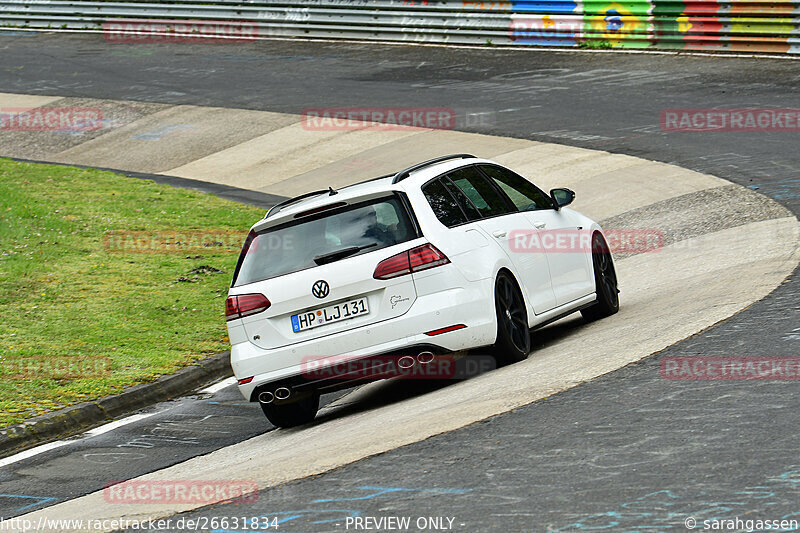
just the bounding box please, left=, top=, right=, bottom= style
left=0, top=159, right=263, bottom=427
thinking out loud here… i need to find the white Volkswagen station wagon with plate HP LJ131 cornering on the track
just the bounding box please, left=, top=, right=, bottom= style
left=226, top=154, right=619, bottom=427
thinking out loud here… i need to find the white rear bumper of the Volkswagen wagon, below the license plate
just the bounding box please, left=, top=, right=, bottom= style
left=231, top=280, right=497, bottom=401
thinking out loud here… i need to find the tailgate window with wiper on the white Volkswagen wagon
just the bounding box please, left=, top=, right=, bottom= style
left=233, top=195, right=418, bottom=287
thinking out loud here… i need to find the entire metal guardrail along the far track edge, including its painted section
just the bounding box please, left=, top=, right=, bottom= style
left=0, top=0, right=800, bottom=54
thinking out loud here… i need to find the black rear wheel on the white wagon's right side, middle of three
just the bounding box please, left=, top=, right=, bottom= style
left=493, top=272, right=531, bottom=366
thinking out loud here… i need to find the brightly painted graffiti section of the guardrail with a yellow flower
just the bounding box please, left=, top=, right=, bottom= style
left=510, top=0, right=800, bottom=53
